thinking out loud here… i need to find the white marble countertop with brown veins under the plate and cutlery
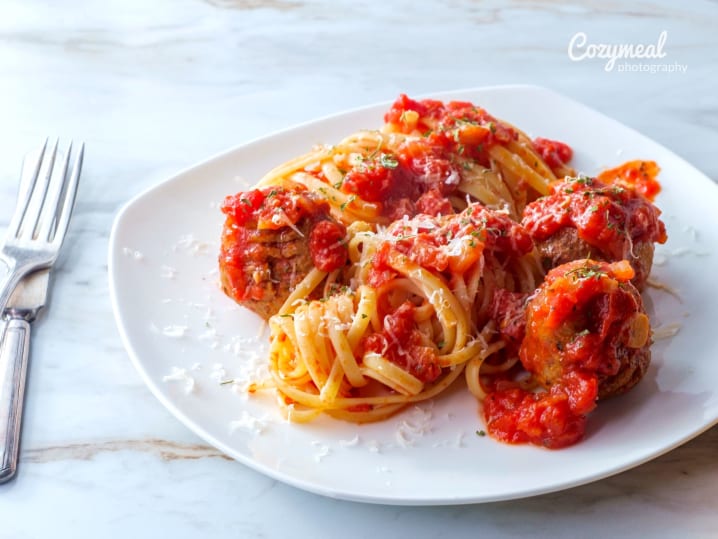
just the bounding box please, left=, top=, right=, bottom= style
left=0, top=0, right=718, bottom=538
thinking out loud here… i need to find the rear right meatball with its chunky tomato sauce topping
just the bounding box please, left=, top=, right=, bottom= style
left=522, top=177, right=666, bottom=290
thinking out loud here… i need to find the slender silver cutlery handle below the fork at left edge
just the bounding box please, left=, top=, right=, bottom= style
left=0, top=318, right=30, bottom=483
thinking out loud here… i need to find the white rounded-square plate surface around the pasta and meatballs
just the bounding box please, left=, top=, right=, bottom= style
left=109, top=86, right=718, bottom=505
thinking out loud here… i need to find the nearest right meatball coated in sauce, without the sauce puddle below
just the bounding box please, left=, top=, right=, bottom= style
left=519, top=259, right=651, bottom=399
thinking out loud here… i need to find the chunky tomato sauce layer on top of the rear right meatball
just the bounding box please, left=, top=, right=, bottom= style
left=521, top=177, right=666, bottom=260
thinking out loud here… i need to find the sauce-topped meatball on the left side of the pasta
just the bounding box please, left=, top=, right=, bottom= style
left=219, top=187, right=346, bottom=319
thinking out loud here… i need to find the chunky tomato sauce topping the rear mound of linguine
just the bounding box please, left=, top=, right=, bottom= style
left=340, top=95, right=518, bottom=220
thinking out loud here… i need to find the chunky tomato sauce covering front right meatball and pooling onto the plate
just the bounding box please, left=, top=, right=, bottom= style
left=484, top=260, right=650, bottom=448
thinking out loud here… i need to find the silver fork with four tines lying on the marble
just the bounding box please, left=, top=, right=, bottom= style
left=0, top=140, right=85, bottom=313
